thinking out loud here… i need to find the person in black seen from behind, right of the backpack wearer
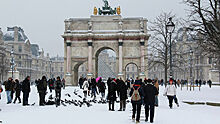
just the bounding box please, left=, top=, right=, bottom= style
left=143, top=79, right=159, bottom=123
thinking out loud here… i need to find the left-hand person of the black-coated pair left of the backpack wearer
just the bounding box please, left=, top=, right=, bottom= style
left=107, top=79, right=117, bottom=111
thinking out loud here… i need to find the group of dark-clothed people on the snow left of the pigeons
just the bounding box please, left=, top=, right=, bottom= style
left=0, top=76, right=65, bottom=106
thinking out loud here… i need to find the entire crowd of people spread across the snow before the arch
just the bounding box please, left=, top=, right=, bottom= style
left=0, top=76, right=215, bottom=123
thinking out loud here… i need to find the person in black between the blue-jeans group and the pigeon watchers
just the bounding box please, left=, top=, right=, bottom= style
left=22, top=76, right=31, bottom=106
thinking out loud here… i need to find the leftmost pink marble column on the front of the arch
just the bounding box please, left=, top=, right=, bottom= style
left=66, top=38, right=72, bottom=74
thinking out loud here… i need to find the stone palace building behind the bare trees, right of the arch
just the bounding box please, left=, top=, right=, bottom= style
left=149, top=28, right=219, bottom=82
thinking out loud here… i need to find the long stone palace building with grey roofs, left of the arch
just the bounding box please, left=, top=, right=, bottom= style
left=0, top=26, right=64, bottom=81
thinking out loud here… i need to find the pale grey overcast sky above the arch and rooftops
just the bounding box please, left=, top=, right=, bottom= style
left=0, top=0, right=186, bottom=56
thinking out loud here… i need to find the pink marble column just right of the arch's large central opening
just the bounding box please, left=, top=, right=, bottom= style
left=118, top=39, right=123, bottom=75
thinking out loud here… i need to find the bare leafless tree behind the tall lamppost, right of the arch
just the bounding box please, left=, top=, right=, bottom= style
left=149, top=12, right=184, bottom=83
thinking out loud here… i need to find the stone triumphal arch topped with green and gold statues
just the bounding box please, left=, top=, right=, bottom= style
left=62, top=2, right=149, bottom=85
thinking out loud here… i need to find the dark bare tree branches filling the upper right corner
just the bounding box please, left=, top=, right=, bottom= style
left=184, top=0, right=220, bottom=58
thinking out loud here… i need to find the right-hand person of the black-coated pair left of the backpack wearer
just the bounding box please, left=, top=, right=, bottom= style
left=118, top=79, right=128, bottom=111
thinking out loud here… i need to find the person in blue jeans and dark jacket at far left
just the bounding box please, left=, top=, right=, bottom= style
left=3, top=77, right=13, bottom=104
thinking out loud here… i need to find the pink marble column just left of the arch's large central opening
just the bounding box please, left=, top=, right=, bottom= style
left=88, top=39, right=92, bottom=75
